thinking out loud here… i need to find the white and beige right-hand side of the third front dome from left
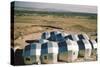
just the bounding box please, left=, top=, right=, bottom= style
left=66, top=40, right=79, bottom=61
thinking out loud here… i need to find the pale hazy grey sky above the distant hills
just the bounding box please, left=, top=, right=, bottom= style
left=15, top=1, right=97, bottom=13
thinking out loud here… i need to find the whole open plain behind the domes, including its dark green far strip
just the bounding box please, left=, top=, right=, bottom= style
left=14, top=11, right=97, bottom=48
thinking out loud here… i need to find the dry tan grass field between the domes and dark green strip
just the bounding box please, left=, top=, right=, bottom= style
left=14, top=15, right=97, bottom=48
